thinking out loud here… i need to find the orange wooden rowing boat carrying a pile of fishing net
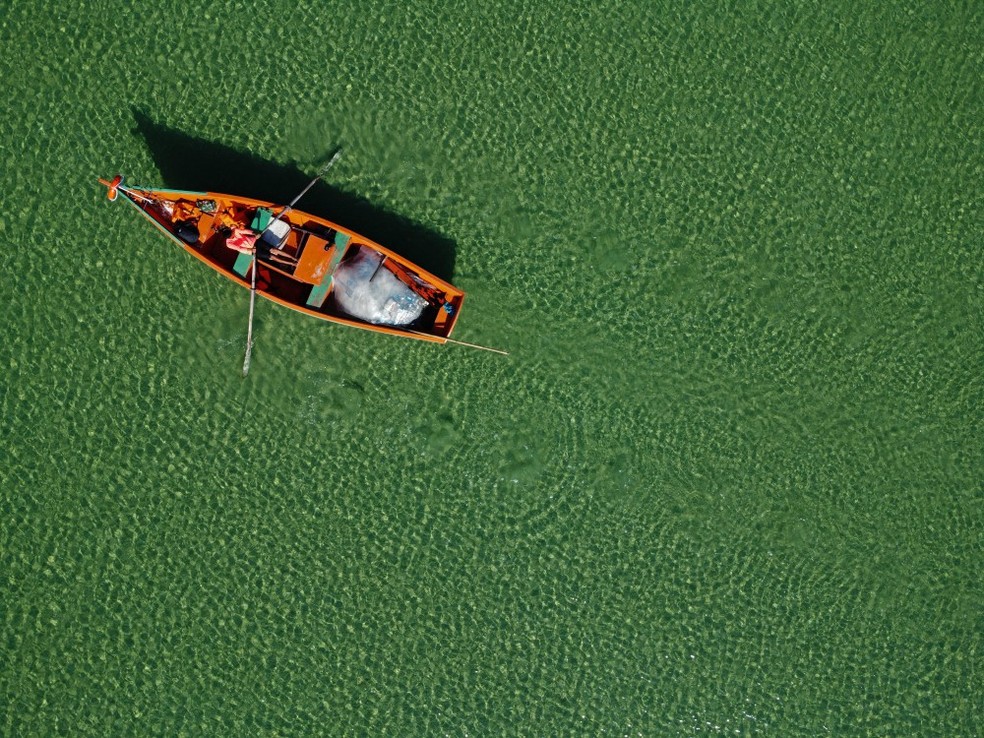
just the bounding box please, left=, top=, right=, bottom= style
left=99, top=176, right=465, bottom=343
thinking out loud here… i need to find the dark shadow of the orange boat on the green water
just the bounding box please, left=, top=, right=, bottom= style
left=133, top=110, right=455, bottom=282
